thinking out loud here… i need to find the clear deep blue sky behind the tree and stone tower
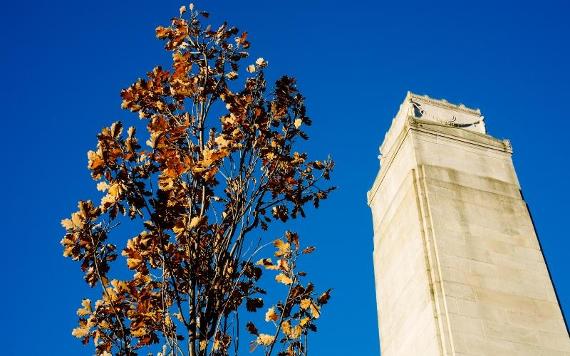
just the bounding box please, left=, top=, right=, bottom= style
left=0, top=0, right=570, bottom=355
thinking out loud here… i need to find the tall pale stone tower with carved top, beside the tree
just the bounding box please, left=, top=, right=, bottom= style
left=368, top=93, right=570, bottom=356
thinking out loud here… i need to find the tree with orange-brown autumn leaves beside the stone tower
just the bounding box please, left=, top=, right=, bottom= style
left=61, top=5, right=334, bottom=355
